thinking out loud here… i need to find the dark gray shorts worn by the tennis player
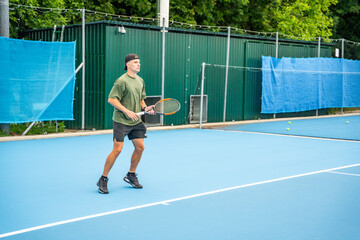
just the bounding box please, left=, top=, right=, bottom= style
left=113, top=121, right=147, bottom=142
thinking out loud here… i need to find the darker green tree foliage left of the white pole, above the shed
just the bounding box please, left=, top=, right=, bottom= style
left=9, top=0, right=157, bottom=38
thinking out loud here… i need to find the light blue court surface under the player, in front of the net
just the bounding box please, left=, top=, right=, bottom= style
left=0, top=129, right=360, bottom=240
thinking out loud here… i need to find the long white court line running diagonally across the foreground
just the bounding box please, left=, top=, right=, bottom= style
left=0, top=163, right=360, bottom=238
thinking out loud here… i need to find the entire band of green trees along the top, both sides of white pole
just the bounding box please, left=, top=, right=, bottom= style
left=10, top=0, right=352, bottom=41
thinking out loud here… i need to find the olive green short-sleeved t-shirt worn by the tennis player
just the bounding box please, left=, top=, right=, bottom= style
left=109, top=73, right=146, bottom=126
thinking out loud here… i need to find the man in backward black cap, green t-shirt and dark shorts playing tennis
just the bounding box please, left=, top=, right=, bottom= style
left=97, top=54, right=155, bottom=194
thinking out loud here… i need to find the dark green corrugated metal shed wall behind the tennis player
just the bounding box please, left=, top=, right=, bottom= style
left=27, top=21, right=331, bottom=129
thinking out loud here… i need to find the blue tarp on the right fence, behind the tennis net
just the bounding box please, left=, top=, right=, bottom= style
left=261, top=56, right=360, bottom=113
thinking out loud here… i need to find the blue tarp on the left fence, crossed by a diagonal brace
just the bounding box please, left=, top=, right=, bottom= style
left=0, top=37, right=75, bottom=123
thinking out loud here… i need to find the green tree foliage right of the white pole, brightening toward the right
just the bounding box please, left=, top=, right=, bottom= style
left=170, top=0, right=337, bottom=39
